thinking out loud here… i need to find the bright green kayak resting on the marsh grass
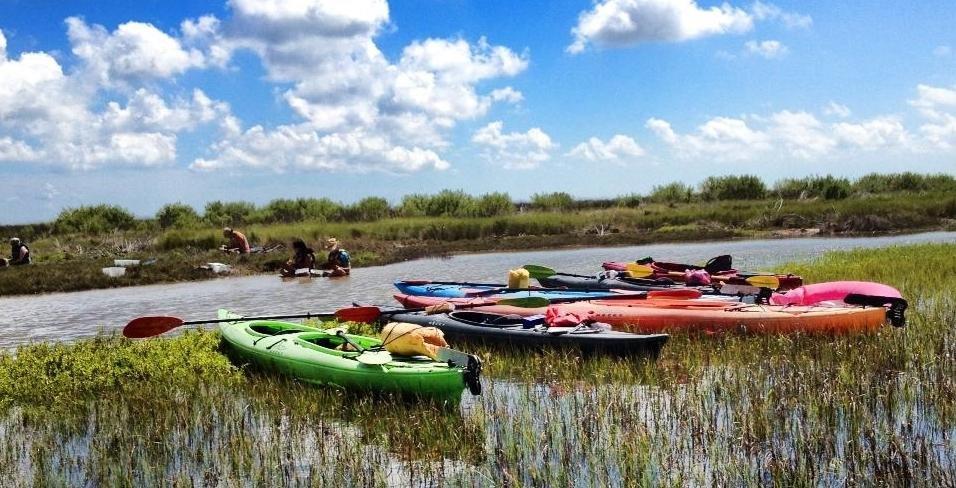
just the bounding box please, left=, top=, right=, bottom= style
left=219, top=310, right=481, bottom=400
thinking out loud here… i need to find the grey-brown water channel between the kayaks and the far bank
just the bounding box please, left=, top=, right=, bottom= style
left=0, top=232, right=956, bottom=348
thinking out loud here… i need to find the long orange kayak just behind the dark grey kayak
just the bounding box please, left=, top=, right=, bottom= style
left=395, top=295, right=886, bottom=334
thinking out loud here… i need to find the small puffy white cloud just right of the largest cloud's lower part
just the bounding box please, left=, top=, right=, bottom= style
left=471, top=121, right=557, bottom=169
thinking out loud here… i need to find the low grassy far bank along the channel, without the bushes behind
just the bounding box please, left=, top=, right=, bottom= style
left=0, top=193, right=956, bottom=295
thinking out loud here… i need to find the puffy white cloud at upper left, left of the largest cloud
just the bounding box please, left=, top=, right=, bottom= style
left=66, top=17, right=205, bottom=85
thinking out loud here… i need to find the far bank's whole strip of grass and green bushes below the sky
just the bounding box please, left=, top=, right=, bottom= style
left=0, top=173, right=956, bottom=295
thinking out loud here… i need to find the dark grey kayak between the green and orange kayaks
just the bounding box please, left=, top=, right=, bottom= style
left=391, top=311, right=668, bottom=358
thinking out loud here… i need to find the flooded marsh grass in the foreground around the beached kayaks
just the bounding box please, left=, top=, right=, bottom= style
left=0, top=245, right=956, bottom=486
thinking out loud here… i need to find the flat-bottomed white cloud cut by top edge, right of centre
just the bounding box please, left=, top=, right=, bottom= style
left=567, top=0, right=754, bottom=54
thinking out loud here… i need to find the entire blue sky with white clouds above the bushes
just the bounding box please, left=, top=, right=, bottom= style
left=0, top=0, right=956, bottom=224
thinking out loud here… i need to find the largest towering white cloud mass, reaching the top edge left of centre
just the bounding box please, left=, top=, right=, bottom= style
left=183, top=0, right=528, bottom=171
